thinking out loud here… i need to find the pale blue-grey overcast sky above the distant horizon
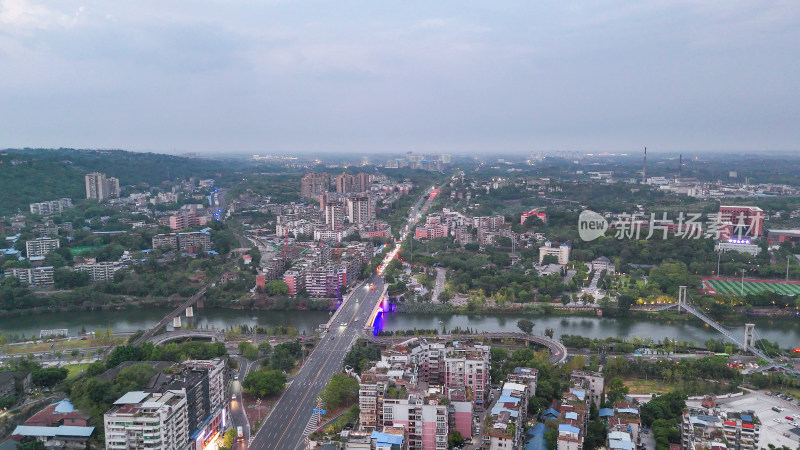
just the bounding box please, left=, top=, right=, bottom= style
left=0, top=0, right=800, bottom=154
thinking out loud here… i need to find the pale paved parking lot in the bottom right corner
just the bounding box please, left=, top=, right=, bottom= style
left=704, top=391, right=800, bottom=448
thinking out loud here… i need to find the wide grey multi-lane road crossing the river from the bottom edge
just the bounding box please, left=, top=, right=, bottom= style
left=249, top=274, right=383, bottom=450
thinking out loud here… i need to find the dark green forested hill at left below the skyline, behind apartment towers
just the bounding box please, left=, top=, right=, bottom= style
left=0, top=149, right=230, bottom=215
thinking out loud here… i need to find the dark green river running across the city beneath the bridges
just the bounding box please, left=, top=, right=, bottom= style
left=0, top=308, right=800, bottom=348
